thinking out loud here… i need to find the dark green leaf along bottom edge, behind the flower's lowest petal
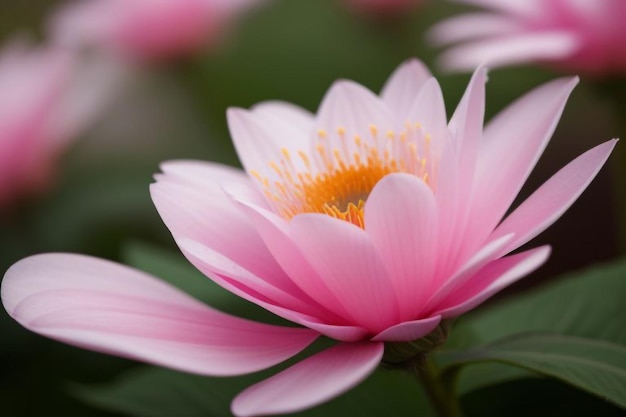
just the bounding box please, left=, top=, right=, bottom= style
left=73, top=367, right=434, bottom=417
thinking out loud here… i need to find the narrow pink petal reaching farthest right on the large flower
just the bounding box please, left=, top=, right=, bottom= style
left=491, top=139, right=617, bottom=250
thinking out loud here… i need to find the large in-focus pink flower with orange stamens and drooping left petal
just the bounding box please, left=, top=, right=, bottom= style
left=2, top=60, right=615, bottom=416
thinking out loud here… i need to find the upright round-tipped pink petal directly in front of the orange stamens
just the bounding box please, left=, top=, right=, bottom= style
left=365, top=173, right=438, bottom=321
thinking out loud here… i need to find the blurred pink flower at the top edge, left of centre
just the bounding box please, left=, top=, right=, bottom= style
left=51, top=0, right=260, bottom=59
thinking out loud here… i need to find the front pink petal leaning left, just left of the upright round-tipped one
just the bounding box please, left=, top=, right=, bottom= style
left=289, top=213, right=399, bottom=332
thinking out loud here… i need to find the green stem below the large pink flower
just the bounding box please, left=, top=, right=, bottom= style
left=411, top=355, right=463, bottom=417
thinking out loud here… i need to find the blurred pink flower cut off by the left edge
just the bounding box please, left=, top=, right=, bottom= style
left=0, top=40, right=120, bottom=208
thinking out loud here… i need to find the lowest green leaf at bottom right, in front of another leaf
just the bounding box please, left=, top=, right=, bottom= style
left=438, top=334, right=626, bottom=408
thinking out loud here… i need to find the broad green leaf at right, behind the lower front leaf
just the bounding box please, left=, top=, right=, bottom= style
left=436, top=260, right=626, bottom=394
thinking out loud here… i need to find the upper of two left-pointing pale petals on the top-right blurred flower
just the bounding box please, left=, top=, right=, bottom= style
left=427, top=12, right=520, bottom=46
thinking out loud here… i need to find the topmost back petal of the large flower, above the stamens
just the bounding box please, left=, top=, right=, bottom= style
left=380, top=59, right=432, bottom=118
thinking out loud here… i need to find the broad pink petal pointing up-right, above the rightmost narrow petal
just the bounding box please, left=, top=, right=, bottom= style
left=465, top=78, right=578, bottom=255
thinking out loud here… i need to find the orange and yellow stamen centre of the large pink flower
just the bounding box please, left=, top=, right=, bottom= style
left=250, top=123, right=434, bottom=228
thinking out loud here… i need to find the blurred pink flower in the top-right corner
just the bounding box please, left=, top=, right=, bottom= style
left=430, top=0, right=626, bottom=75
